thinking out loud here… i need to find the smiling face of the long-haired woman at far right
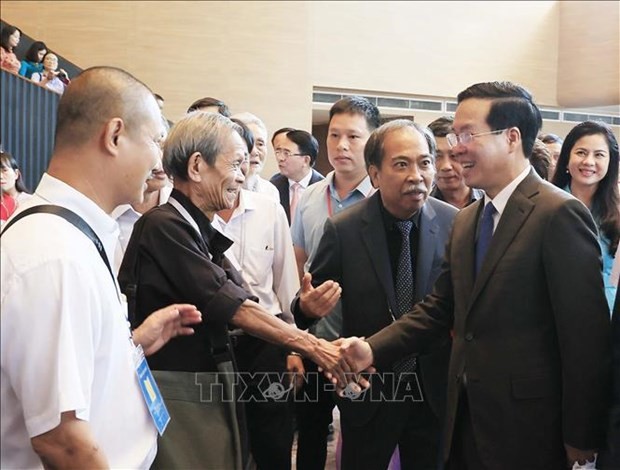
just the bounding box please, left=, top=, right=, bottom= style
left=568, top=134, right=609, bottom=188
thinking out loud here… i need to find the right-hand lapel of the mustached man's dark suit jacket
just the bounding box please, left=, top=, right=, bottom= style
left=414, top=201, right=439, bottom=302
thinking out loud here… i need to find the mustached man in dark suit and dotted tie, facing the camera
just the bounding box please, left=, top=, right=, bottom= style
left=294, top=120, right=457, bottom=469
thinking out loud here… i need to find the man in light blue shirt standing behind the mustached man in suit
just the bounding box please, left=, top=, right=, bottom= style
left=291, top=96, right=380, bottom=470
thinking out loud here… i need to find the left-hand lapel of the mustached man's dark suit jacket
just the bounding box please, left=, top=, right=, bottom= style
left=362, top=192, right=397, bottom=312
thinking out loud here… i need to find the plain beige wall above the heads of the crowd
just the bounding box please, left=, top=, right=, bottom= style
left=2, top=0, right=618, bottom=176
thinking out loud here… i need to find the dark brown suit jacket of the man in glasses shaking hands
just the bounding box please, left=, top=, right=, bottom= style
left=368, top=171, right=611, bottom=470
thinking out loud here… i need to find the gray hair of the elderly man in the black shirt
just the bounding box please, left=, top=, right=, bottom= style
left=164, top=111, right=241, bottom=181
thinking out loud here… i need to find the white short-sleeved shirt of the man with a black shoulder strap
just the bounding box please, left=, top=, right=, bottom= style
left=0, top=174, right=157, bottom=468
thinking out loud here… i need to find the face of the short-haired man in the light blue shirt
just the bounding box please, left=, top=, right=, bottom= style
left=327, top=113, right=370, bottom=182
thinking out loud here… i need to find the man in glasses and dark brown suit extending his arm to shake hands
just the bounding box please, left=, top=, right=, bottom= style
left=342, top=82, right=611, bottom=470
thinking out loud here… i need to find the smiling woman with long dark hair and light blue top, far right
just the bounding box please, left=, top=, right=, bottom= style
left=552, top=121, right=620, bottom=310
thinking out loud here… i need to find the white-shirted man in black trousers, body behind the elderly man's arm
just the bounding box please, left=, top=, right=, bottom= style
left=213, top=189, right=304, bottom=470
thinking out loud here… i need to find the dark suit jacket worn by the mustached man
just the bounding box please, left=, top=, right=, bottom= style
left=296, top=192, right=457, bottom=425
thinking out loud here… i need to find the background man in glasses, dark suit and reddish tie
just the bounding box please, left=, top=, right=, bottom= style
left=269, top=129, right=323, bottom=225
